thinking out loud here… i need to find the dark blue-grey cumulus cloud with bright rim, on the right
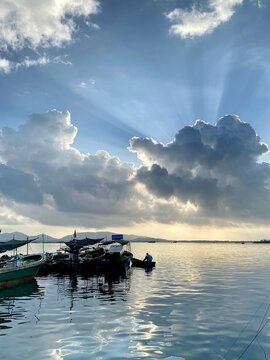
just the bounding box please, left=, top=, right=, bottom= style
left=130, top=115, right=270, bottom=222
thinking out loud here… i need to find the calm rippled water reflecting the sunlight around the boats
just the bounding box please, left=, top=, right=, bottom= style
left=0, top=243, right=270, bottom=360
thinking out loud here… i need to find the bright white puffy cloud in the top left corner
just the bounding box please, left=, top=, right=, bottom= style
left=0, top=0, right=100, bottom=50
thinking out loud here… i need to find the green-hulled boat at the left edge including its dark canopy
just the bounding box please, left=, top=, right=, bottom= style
left=0, top=239, right=46, bottom=288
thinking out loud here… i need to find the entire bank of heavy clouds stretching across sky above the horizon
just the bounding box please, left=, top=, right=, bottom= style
left=0, top=110, right=270, bottom=228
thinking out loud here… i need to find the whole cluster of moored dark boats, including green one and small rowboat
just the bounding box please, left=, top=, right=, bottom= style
left=0, top=235, right=155, bottom=288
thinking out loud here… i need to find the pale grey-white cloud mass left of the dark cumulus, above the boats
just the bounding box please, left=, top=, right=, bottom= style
left=0, top=110, right=150, bottom=226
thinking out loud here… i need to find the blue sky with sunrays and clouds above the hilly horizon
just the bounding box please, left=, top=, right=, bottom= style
left=0, top=0, right=270, bottom=241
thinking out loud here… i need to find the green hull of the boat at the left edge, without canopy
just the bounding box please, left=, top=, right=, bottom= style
left=0, top=254, right=46, bottom=288
